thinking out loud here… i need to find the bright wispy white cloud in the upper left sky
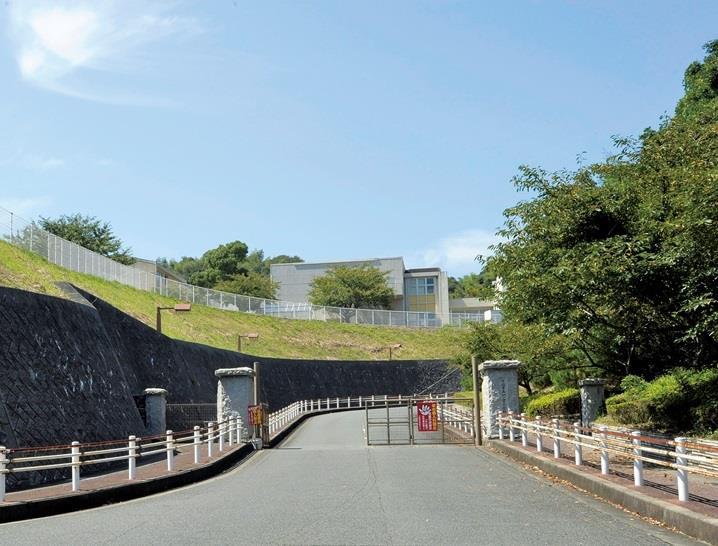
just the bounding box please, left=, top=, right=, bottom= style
left=9, top=0, right=200, bottom=106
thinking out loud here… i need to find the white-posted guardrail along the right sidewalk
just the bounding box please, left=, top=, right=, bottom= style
left=497, top=412, right=718, bottom=501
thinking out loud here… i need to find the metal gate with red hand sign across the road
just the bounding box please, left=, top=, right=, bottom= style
left=364, top=396, right=474, bottom=446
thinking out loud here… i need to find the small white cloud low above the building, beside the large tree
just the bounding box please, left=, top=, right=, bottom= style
left=407, top=229, right=499, bottom=276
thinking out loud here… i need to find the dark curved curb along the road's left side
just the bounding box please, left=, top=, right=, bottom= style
left=0, top=444, right=254, bottom=523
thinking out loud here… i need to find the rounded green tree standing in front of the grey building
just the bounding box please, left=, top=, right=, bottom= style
left=309, top=265, right=394, bottom=309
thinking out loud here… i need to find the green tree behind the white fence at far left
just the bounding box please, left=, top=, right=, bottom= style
left=39, top=214, right=135, bottom=265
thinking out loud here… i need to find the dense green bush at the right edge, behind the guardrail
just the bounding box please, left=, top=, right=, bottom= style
left=606, top=368, right=718, bottom=433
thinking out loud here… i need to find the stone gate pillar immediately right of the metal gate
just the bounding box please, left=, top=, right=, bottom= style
left=479, top=360, right=521, bottom=438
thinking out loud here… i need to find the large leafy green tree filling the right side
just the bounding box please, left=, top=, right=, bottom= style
left=492, top=42, right=718, bottom=377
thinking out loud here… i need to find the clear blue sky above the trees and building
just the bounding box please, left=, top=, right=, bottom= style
left=0, top=0, right=718, bottom=275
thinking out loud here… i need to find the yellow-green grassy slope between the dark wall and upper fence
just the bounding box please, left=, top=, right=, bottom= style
left=0, top=242, right=466, bottom=360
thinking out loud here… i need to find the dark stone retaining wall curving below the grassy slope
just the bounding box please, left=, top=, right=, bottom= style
left=0, top=285, right=459, bottom=488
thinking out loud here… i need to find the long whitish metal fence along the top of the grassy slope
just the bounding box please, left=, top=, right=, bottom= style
left=0, top=207, right=500, bottom=328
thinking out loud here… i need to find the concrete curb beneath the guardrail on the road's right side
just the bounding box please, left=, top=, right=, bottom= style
left=485, top=440, right=718, bottom=544
